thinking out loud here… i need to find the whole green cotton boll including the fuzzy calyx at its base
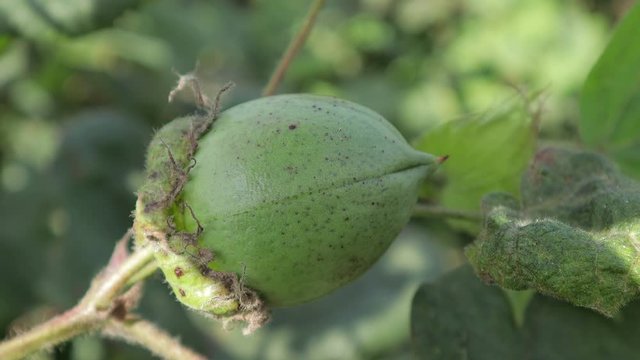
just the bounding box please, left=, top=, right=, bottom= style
left=136, top=95, right=438, bottom=332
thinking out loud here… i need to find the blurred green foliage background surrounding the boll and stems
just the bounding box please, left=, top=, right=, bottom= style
left=0, top=0, right=633, bottom=360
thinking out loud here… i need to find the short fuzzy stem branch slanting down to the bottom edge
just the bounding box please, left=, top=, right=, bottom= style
left=102, top=318, right=206, bottom=360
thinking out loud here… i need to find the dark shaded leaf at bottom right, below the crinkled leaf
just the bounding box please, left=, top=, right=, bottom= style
left=411, top=266, right=640, bottom=360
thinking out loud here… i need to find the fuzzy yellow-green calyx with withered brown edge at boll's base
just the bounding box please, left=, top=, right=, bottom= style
left=134, top=111, right=269, bottom=333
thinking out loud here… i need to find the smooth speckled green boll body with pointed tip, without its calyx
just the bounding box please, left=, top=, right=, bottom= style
left=183, top=95, right=435, bottom=306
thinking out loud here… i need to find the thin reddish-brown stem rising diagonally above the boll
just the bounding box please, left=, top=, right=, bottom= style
left=262, top=0, right=325, bottom=96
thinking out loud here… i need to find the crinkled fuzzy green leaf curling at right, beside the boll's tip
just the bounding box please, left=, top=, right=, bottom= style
left=466, top=148, right=640, bottom=316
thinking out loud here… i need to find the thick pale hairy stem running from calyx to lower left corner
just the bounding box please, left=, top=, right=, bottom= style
left=0, top=246, right=154, bottom=360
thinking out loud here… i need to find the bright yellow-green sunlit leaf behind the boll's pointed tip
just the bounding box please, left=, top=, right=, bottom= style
left=415, top=98, right=535, bottom=232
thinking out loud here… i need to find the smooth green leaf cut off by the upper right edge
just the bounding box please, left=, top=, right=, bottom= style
left=580, top=4, right=640, bottom=177
